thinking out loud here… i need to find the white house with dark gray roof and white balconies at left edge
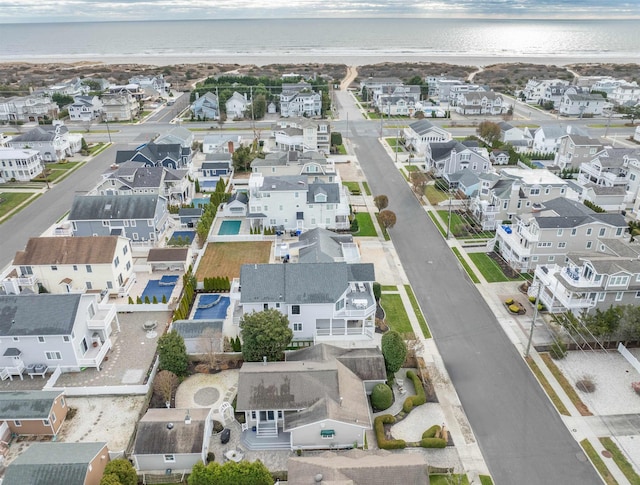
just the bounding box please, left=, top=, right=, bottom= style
left=0, top=293, right=119, bottom=374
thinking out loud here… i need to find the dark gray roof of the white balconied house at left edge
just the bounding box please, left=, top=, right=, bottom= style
left=0, top=294, right=82, bottom=337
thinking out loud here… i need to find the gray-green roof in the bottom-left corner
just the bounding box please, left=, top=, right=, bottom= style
left=2, top=443, right=107, bottom=485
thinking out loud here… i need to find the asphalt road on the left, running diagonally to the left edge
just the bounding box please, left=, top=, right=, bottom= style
left=0, top=145, right=124, bottom=268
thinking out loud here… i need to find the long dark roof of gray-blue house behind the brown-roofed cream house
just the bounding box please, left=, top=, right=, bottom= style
left=69, top=195, right=166, bottom=221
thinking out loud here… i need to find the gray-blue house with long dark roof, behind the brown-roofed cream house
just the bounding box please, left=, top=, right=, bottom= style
left=67, top=195, right=169, bottom=244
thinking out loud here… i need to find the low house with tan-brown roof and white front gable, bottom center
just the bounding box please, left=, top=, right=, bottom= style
left=236, top=344, right=386, bottom=450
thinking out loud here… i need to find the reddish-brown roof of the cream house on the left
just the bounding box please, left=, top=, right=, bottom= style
left=13, top=236, right=118, bottom=266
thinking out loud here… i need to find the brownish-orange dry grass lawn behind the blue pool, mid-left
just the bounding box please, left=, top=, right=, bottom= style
left=196, top=241, right=271, bottom=281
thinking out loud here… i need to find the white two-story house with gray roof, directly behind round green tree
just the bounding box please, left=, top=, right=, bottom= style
left=240, top=262, right=376, bottom=342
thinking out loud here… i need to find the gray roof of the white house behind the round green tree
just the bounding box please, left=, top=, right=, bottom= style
left=240, top=263, right=375, bottom=304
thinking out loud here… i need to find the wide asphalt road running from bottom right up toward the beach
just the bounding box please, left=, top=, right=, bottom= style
left=342, top=89, right=602, bottom=485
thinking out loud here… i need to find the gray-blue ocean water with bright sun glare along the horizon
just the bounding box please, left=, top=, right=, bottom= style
left=0, top=18, right=640, bottom=64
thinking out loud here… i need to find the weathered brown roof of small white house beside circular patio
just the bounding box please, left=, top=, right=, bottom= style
left=131, top=408, right=211, bottom=455
